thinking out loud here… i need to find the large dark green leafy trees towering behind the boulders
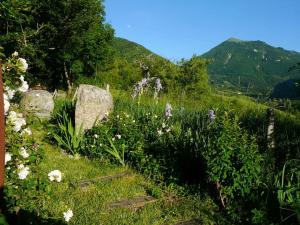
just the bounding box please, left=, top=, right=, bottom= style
left=0, top=0, right=114, bottom=88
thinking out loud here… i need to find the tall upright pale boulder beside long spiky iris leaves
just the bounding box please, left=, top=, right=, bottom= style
left=75, top=84, right=113, bottom=129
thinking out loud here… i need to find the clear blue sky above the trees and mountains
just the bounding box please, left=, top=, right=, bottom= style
left=104, top=0, right=300, bottom=60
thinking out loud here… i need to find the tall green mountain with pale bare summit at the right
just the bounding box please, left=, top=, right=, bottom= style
left=202, top=38, right=300, bottom=95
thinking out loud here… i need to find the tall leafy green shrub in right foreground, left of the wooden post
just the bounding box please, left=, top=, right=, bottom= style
left=203, top=112, right=263, bottom=203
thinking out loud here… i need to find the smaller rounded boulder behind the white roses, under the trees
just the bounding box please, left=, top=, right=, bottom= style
left=22, top=90, right=54, bottom=119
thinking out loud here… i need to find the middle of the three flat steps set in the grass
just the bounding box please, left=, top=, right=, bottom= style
left=108, top=195, right=157, bottom=209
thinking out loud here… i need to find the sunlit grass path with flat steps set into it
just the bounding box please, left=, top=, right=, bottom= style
left=29, top=123, right=223, bottom=225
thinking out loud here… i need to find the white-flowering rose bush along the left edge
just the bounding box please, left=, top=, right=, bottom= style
left=2, top=52, right=73, bottom=222
